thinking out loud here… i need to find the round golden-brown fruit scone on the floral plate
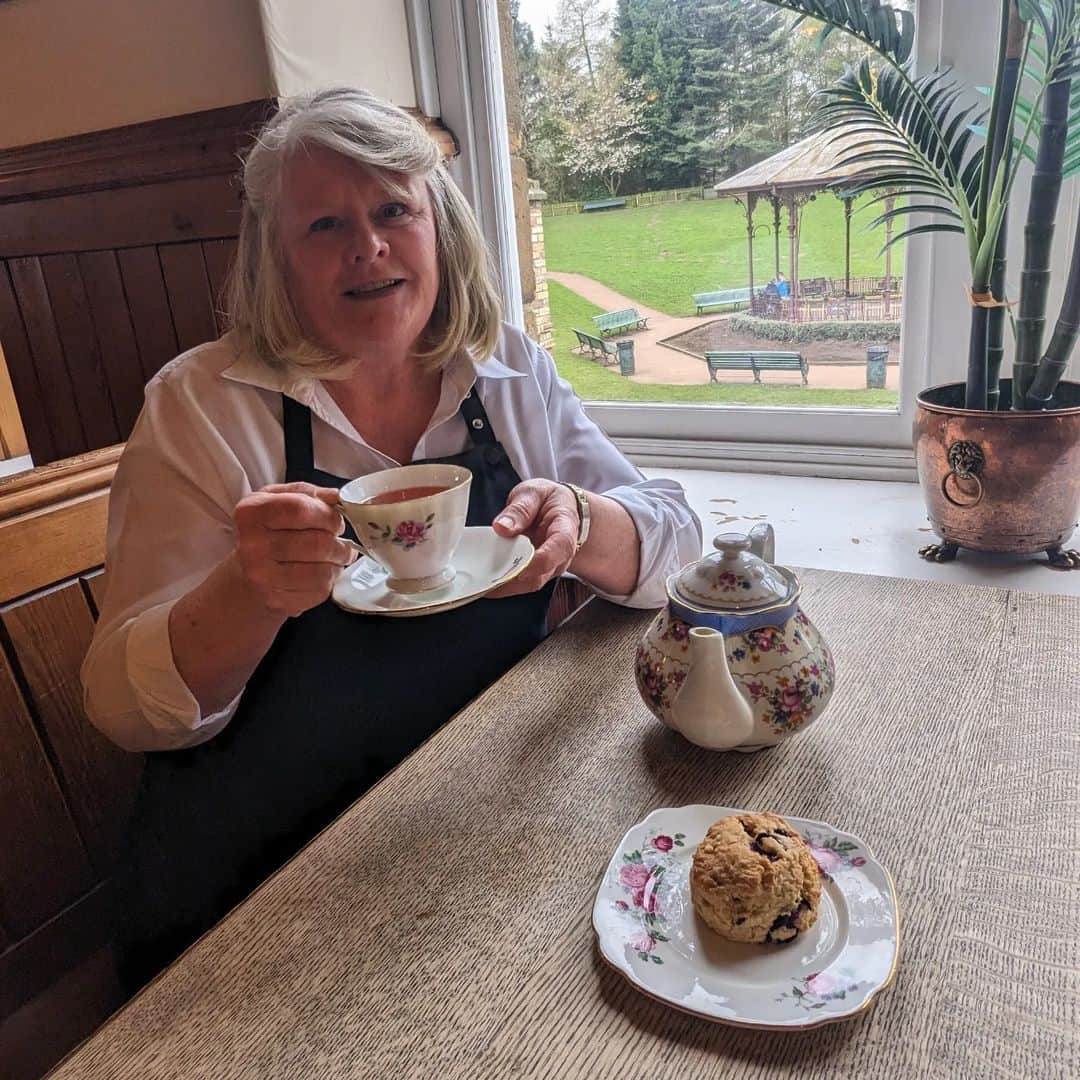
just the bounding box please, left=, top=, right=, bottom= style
left=690, top=813, right=821, bottom=942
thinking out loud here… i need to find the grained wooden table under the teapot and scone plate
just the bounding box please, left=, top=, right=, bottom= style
left=50, top=570, right=1080, bottom=1080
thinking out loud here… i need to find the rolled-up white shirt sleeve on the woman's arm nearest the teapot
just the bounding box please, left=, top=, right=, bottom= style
left=535, top=346, right=701, bottom=608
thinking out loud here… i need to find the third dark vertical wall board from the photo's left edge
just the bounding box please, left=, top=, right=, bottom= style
left=41, top=255, right=124, bottom=449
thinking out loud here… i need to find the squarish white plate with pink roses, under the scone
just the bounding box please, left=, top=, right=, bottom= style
left=593, top=806, right=900, bottom=1030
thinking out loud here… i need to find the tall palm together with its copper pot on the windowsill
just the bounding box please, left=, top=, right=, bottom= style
left=770, top=0, right=1080, bottom=568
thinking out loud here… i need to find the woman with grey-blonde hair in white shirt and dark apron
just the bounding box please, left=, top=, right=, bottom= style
left=83, top=90, right=701, bottom=986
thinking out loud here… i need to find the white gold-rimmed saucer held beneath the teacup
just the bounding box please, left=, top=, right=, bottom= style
left=332, top=526, right=534, bottom=618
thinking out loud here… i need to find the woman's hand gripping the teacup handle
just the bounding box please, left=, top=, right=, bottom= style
left=233, top=483, right=356, bottom=617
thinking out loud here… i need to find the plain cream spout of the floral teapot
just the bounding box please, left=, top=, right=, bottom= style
left=672, top=626, right=754, bottom=750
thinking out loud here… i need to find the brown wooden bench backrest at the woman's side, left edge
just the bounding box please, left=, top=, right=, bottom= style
left=0, top=447, right=141, bottom=1076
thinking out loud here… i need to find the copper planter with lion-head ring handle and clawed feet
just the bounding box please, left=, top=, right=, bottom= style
left=914, top=379, right=1080, bottom=565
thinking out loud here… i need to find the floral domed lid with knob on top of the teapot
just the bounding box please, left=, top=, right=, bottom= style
left=671, top=532, right=798, bottom=613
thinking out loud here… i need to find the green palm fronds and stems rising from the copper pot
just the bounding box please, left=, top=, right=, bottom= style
left=769, top=0, right=1080, bottom=409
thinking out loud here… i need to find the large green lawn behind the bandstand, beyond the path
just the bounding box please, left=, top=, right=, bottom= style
left=543, top=193, right=904, bottom=315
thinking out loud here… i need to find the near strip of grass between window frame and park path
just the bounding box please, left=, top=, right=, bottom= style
left=548, top=281, right=897, bottom=408
